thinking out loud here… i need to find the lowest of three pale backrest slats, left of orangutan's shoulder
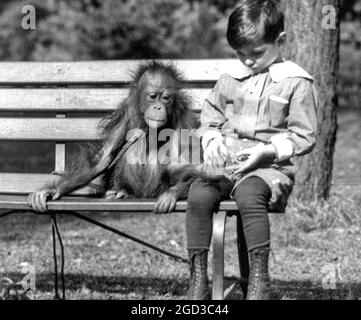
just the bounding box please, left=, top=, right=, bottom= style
left=0, top=117, right=101, bottom=141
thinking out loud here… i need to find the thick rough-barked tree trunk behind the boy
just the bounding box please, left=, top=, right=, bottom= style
left=283, top=0, right=340, bottom=201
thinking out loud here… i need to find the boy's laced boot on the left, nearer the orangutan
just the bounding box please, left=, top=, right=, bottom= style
left=188, top=250, right=211, bottom=300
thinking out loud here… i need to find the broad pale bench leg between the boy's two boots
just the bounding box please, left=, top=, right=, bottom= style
left=212, top=211, right=227, bottom=300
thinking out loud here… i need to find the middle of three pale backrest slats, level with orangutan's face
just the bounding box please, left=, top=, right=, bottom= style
left=0, top=88, right=210, bottom=113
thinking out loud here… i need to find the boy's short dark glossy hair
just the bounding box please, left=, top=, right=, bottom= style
left=227, top=0, right=284, bottom=50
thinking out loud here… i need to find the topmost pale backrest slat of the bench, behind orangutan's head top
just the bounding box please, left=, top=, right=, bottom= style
left=0, top=59, right=245, bottom=85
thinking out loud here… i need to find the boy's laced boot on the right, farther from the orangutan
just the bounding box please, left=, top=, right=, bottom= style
left=246, top=248, right=271, bottom=300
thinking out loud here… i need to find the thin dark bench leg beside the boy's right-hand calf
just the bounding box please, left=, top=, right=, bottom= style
left=237, top=214, right=249, bottom=298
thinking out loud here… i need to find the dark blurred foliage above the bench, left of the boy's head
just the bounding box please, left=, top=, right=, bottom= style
left=0, top=0, right=231, bottom=61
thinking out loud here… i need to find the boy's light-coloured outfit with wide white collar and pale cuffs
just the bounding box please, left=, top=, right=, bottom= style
left=198, top=61, right=317, bottom=211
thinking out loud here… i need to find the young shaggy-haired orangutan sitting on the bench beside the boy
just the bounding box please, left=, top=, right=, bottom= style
left=28, top=62, right=200, bottom=213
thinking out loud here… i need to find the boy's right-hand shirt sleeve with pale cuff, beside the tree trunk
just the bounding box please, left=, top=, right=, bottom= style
left=270, top=79, right=317, bottom=162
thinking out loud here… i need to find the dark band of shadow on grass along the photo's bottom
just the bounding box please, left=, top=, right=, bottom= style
left=4, top=273, right=361, bottom=300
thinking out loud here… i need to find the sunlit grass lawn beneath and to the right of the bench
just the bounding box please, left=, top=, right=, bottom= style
left=0, top=111, right=361, bottom=300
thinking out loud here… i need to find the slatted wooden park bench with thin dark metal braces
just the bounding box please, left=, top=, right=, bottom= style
left=0, top=59, right=282, bottom=299
